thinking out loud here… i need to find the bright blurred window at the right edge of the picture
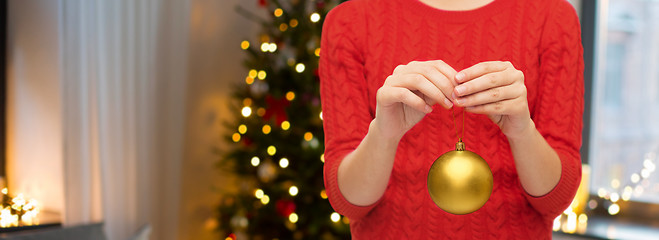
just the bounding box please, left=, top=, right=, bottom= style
left=584, top=0, right=659, bottom=204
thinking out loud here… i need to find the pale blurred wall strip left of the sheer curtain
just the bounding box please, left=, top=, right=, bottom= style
left=7, top=0, right=64, bottom=216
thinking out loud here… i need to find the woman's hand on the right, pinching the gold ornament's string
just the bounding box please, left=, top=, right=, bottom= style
left=452, top=61, right=534, bottom=138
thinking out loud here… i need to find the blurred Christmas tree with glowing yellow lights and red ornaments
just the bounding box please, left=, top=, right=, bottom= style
left=218, top=0, right=349, bottom=239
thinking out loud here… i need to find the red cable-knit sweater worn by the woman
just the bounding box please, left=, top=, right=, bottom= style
left=320, top=0, right=583, bottom=239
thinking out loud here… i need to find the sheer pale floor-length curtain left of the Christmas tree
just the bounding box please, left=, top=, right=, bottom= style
left=59, top=0, right=189, bottom=239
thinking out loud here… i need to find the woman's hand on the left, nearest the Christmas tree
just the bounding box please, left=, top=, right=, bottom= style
left=373, top=60, right=457, bottom=141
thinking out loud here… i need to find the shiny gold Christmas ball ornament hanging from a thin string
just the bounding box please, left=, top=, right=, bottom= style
left=428, top=140, right=493, bottom=214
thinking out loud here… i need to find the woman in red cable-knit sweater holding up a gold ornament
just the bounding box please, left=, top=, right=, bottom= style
left=320, top=0, right=583, bottom=239
